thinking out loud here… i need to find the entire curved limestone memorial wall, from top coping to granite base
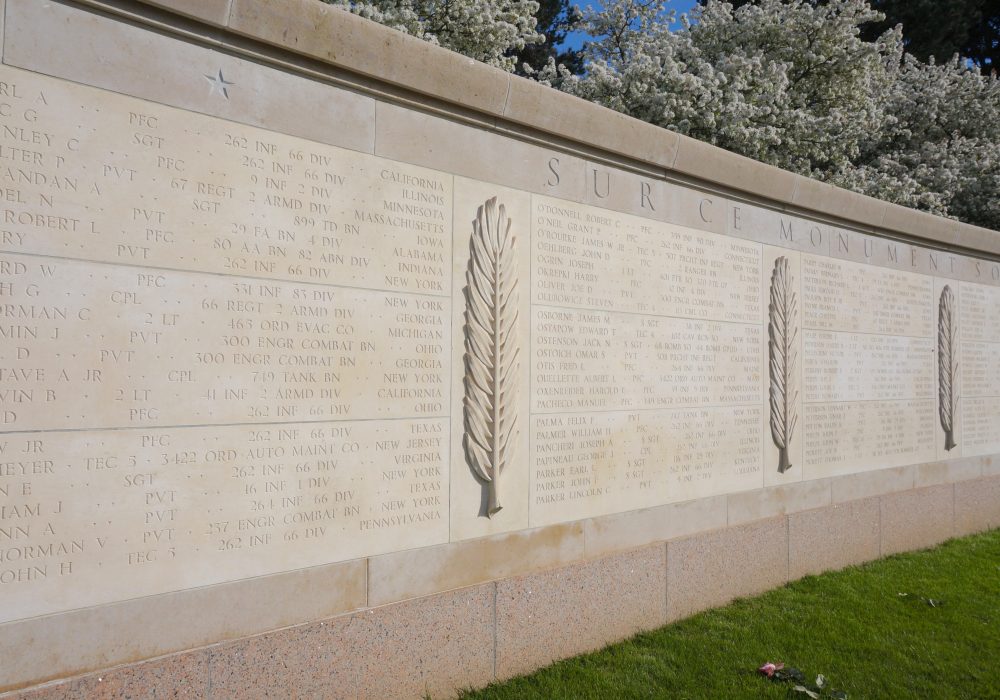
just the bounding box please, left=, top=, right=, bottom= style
left=0, top=0, right=1000, bottom=697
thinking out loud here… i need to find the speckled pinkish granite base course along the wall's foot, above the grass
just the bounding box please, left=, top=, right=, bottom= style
left=9, top=476, right=1000, bottom=700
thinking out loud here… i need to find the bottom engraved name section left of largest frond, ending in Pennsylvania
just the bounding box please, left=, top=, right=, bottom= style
left=0, top=419, right=448, bottom=622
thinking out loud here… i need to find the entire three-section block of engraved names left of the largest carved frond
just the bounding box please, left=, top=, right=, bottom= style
left=0, top=61, right=452, bottom=622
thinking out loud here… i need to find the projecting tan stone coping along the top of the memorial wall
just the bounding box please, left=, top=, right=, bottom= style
left=105, top=0, right=1000, bottom=256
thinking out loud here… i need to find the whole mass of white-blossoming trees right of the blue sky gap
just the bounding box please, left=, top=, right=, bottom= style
left=538, top=0, right=1000, bottom=228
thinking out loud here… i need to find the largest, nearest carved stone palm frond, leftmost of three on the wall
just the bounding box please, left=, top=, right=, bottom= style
left=463, top=197, right=520, bottom=517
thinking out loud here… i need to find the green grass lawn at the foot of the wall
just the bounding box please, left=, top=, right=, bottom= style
left=462, top=530, right=1000, bottom=700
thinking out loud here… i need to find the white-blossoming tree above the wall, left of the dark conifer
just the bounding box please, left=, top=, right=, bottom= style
left=324, top=0, right=545, bottom=71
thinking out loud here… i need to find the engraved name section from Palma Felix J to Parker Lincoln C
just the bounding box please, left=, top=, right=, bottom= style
left=531, top=405, right=763, bottom=526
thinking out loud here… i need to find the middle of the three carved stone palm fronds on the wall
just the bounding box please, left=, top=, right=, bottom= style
left=767, top=255, right=799, bottom=474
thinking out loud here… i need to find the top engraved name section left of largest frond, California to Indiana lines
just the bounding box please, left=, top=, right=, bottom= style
left=0, top=63, right=451, bottom=295
